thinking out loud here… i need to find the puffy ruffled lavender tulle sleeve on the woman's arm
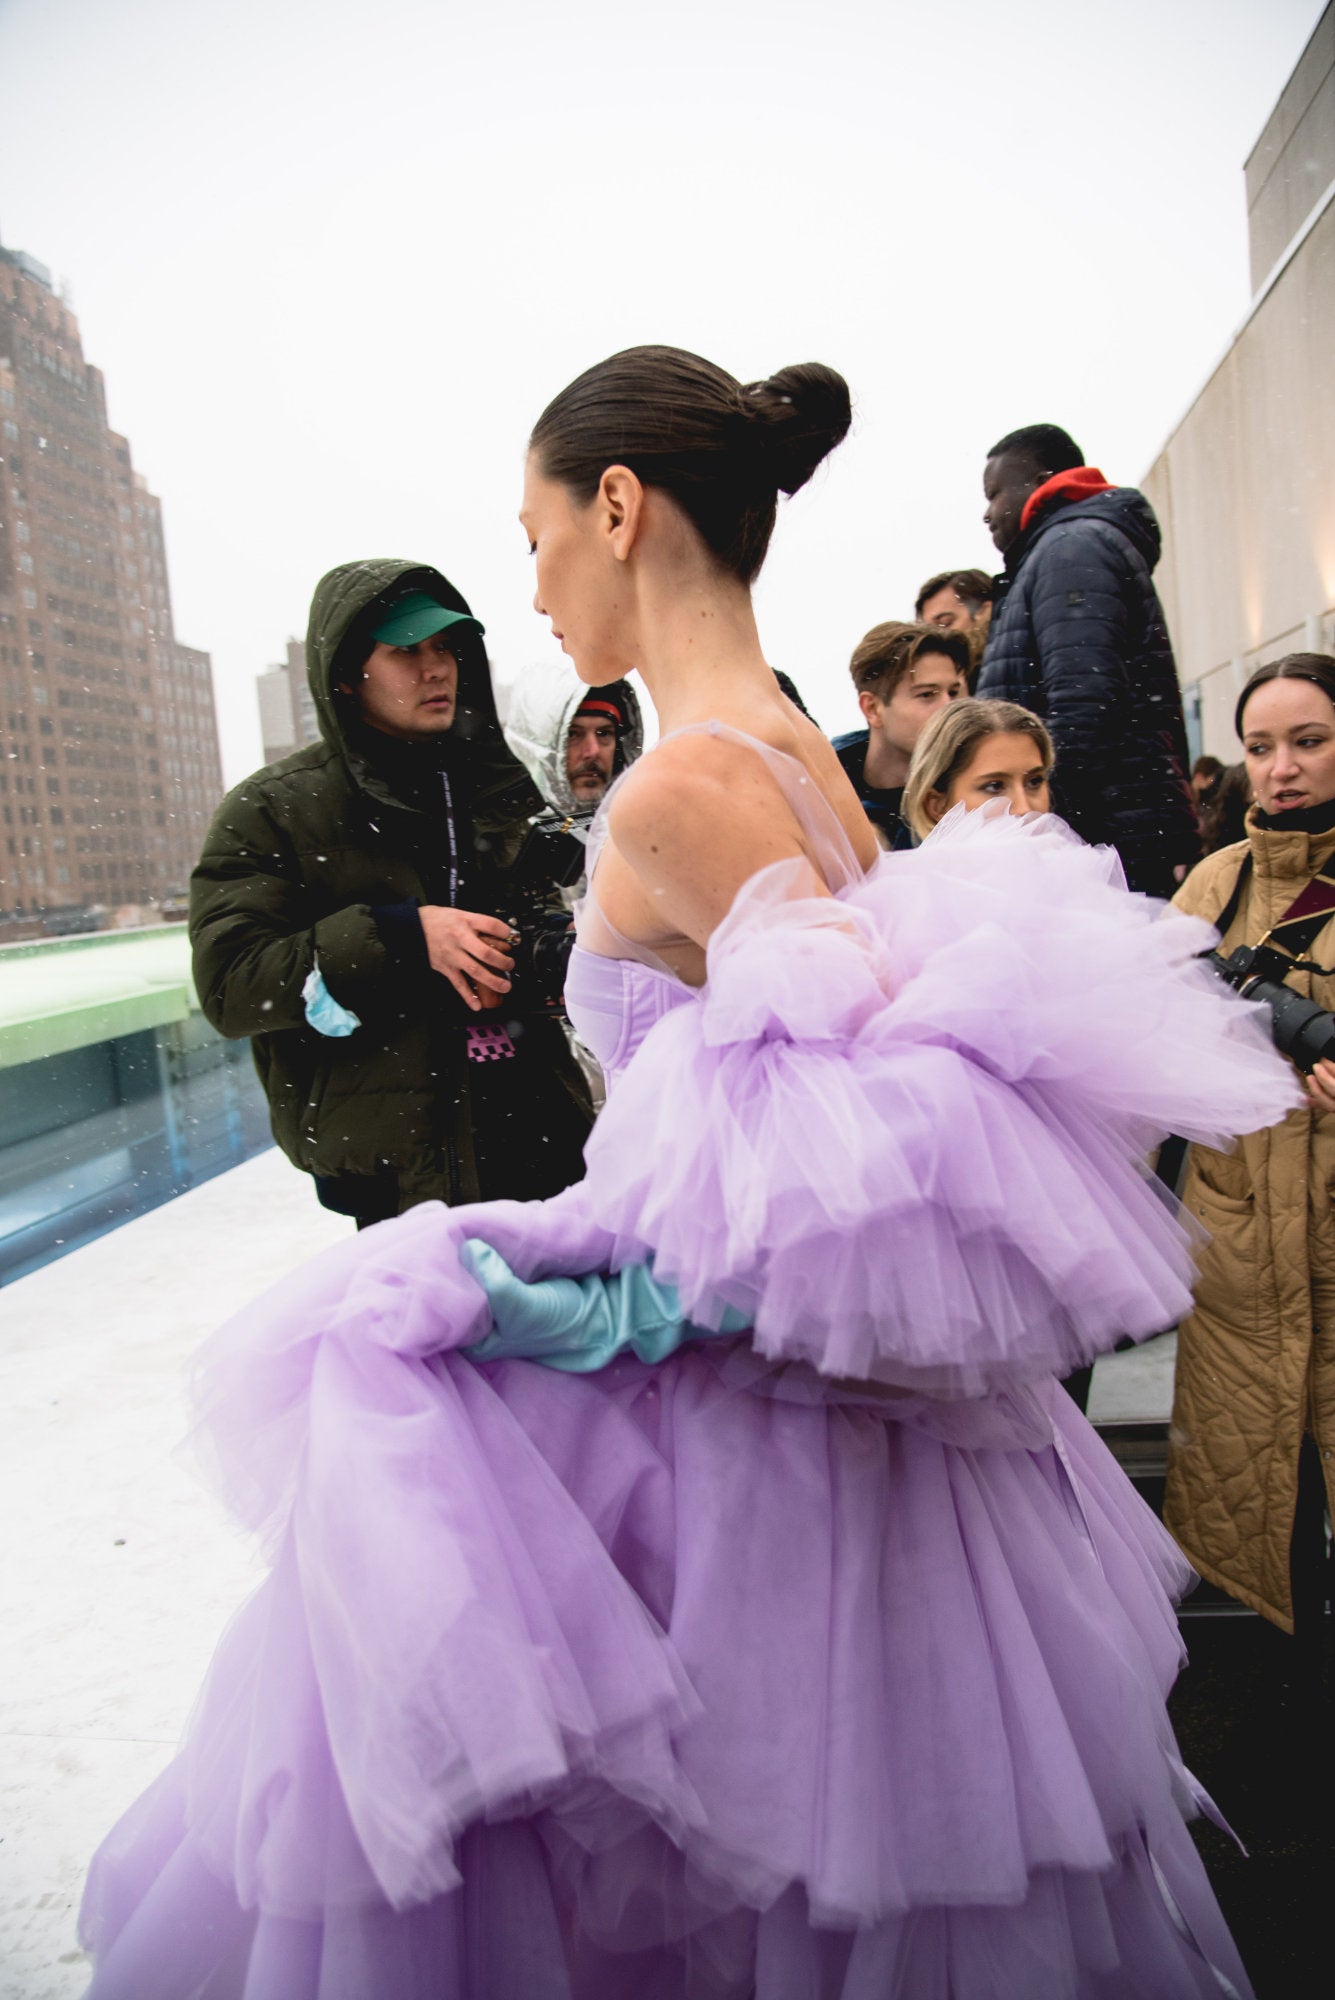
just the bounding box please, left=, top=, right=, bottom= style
left=584, top=810, right=1295, bottom=1396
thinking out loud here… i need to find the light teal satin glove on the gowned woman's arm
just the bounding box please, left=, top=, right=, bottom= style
left=462, top=1236, right=749, bottom=1374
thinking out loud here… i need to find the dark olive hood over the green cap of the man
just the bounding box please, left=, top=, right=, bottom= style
left=306, top=556, right=538, bottom=812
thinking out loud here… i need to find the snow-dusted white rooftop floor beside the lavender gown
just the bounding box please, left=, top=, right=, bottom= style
left=0, top=1152, right=1171, bottom=2000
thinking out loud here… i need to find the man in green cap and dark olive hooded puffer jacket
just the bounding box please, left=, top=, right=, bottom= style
left=190, top=560, right=592, bottom=1226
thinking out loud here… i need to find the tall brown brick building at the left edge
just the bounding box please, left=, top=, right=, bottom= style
left=0, top=246, right=222, bottom=920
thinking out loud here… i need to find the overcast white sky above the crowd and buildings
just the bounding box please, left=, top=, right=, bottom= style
left=0, top=0, right=1321, bottom=782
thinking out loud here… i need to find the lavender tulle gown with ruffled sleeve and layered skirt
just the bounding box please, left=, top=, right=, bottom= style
left=82, top=726, right=1293, bottom=2000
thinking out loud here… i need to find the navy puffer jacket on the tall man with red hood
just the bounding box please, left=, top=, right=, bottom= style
left=975, top=486, right=1201, bottom=896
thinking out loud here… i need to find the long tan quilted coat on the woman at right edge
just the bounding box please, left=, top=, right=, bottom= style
left=1163, top=822, right=1335, bottom=1632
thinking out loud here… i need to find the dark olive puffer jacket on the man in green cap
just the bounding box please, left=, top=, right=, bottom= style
left=190, top=560, right=592, bottom=1218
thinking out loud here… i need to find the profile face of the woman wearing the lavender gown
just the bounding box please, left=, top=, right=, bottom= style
left=520, top=452, right=636, bottom=688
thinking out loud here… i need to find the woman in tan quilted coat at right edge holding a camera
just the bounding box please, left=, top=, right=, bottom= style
left=1163, top=654, right=1335, bottom=1632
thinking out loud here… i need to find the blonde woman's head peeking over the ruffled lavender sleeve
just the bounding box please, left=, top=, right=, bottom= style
left=901, top=696, right=1053, bottom=840
